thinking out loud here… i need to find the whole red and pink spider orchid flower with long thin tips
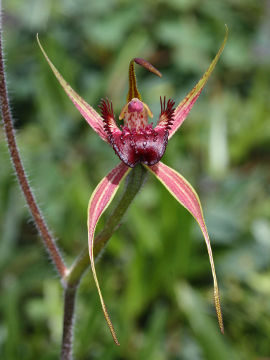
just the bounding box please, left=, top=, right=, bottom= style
left=37, top=27, right=228, bottom=345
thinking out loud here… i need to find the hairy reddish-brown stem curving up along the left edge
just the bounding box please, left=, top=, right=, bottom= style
left=0, top=14, right=67, bottom=278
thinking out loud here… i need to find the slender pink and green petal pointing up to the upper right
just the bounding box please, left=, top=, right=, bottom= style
left=169, top=25, right=228, bottom=139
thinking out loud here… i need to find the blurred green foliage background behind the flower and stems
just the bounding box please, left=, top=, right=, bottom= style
left=0, top=0, right=270, bottom=360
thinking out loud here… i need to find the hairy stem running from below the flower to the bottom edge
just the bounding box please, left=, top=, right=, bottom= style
left=61, top=165, right=146, bottom=360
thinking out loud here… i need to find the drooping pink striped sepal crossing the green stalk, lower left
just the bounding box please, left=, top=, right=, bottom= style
left=87, top=162, right=131, bottom=345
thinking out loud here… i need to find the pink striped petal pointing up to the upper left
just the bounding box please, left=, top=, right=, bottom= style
left=37, top=35, right=108, bottom=142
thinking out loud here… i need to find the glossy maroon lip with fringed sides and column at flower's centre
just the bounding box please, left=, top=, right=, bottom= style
left=99, top=98, right=174, bottom=167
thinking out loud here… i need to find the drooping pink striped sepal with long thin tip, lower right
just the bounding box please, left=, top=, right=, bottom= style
left=147, top=162, right=224, bottom=333
